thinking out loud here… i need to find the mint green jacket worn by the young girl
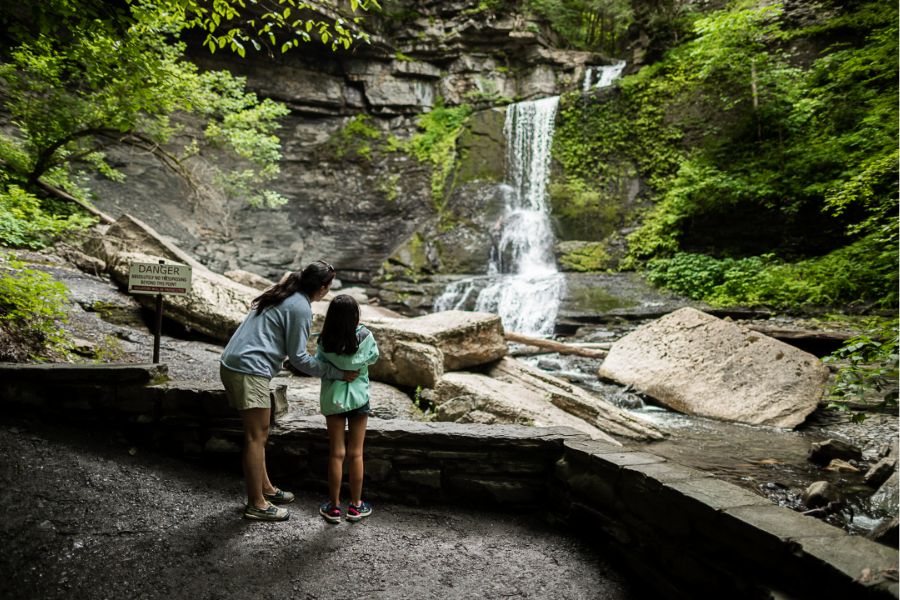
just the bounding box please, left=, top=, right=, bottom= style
left=316, top=325, right=378, bottom=415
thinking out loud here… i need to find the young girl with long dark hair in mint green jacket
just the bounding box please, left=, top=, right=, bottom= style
left=316, top=294, right=378, bottom=523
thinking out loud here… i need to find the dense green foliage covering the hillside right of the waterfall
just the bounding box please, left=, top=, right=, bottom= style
left=553, top=0, right=898, bottom=308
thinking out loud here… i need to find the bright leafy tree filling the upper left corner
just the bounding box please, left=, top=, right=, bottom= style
left=0, top=0, right=378, bottom=220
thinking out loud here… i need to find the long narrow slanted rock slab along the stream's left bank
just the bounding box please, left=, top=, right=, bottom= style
left=487, top=357, right=664, bottom=441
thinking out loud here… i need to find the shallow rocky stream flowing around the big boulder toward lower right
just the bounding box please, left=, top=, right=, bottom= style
left=519, top=321, right=898, bottom=534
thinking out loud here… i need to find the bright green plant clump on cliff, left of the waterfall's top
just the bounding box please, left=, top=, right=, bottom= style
left=404, top=102, right=472, bottom=210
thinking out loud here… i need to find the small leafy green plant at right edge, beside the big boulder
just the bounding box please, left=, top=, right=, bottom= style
left=823, top=319, right=898, bottom=422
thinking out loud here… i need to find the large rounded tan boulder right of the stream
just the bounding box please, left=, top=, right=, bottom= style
left=599, top=308, right=828, bottom=428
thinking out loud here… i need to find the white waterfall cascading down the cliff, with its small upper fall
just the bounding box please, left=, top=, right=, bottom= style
left=434, top=61, right=625, bottom=336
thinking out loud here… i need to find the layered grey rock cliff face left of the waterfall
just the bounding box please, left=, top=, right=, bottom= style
left=86, top=0, right=609, bottom=290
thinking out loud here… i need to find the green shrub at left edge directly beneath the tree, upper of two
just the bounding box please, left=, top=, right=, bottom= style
left=0, top=184, right=95, bottom=250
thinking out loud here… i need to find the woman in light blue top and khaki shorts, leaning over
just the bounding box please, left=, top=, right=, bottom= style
left=219, top=261, right=358, bottom=521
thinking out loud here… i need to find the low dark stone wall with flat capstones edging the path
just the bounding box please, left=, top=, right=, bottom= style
left=0, top=364, right=898, bottom=599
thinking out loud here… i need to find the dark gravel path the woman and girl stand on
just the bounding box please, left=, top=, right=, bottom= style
left=0, top=418, right=640, bottom=600
